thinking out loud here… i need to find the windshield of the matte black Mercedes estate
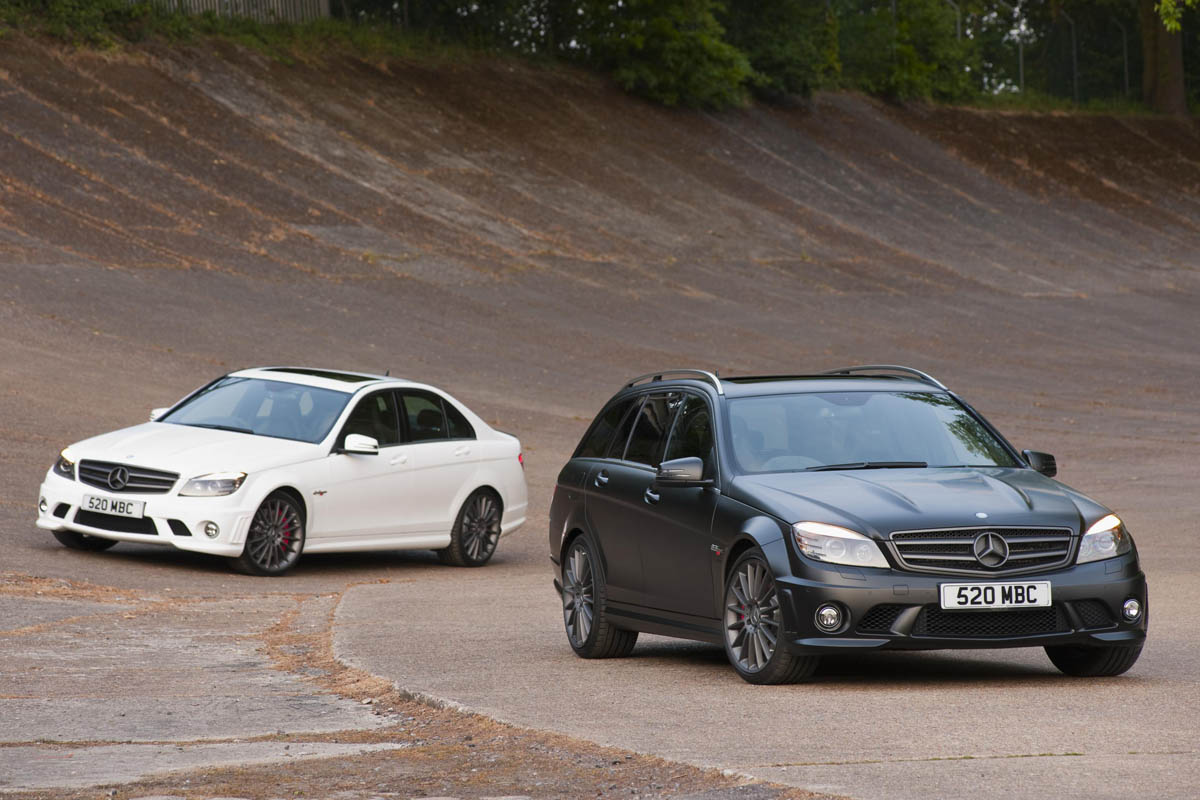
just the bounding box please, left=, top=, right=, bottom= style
left=730, top=392, right=1016, bottom=473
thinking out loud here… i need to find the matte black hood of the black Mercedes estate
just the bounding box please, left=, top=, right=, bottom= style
left=730, top=468, right=1108, bottom=539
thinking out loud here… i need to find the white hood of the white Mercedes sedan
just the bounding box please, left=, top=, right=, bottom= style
left=70, top=422, right=324, bottom=477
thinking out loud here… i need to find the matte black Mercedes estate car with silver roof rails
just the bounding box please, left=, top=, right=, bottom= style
left=550, top=366, right=1147, bottom=684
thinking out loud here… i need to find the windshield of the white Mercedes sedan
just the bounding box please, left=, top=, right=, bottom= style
left=158, top=377, right=350, bottom=444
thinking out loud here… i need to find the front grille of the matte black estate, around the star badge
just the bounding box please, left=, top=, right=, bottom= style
left=890, top=528, right=1074, bottom=575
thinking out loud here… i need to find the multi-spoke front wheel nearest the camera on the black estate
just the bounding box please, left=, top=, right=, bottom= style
left=724, top=548, right=820, bottom=684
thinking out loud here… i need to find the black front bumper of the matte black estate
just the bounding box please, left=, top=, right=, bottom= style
left=776, top=553, right=1148, bottom=655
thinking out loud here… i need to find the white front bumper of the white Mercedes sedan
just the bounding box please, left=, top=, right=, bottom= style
left=37, top=471, right=256, bottom=557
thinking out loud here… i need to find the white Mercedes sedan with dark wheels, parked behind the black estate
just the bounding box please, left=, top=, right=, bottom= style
left=37, top=367, right=527, bottom=576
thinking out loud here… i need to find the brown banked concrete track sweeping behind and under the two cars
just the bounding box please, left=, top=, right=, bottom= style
left=0, top=37, right=1200, bottom=796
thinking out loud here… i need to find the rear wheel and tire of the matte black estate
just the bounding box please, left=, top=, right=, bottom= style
left=562, top=535, right=637, bottom=658
